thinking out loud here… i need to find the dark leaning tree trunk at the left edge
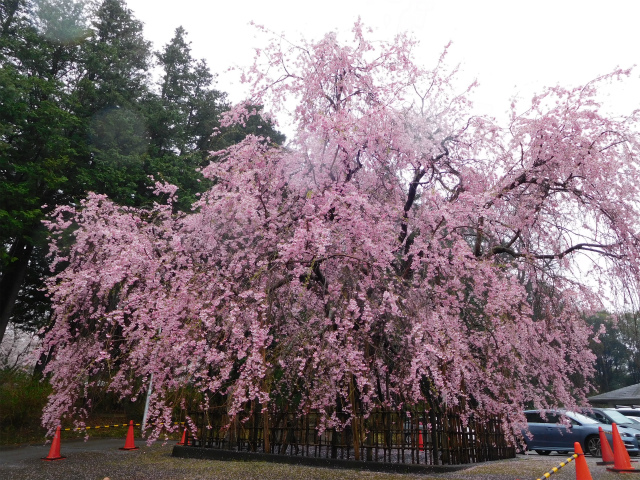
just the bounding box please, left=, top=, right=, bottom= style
left=0, top=238, right=33, bottom=343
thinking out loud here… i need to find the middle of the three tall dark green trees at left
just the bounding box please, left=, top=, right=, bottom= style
left=75, top=0, right=152, bottom=205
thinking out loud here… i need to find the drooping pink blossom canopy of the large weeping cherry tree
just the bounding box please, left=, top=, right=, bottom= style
left=38, top=23, right=640, bottom=435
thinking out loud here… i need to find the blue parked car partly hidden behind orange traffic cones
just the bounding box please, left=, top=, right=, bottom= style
left=522, top=410, right=640, bottom=457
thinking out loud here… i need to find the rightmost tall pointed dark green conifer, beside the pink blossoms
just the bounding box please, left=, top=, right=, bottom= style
left=146, top=27, right=285, bottom=209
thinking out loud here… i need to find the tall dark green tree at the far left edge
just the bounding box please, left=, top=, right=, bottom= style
left=0, top=0, right=86, bottom=339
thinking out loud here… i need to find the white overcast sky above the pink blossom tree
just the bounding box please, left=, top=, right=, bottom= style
left=127, top=0, right=640, bottom=124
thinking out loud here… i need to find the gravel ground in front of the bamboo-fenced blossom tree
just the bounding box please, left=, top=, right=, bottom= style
left=0, top=439, right=632, bottom=480
